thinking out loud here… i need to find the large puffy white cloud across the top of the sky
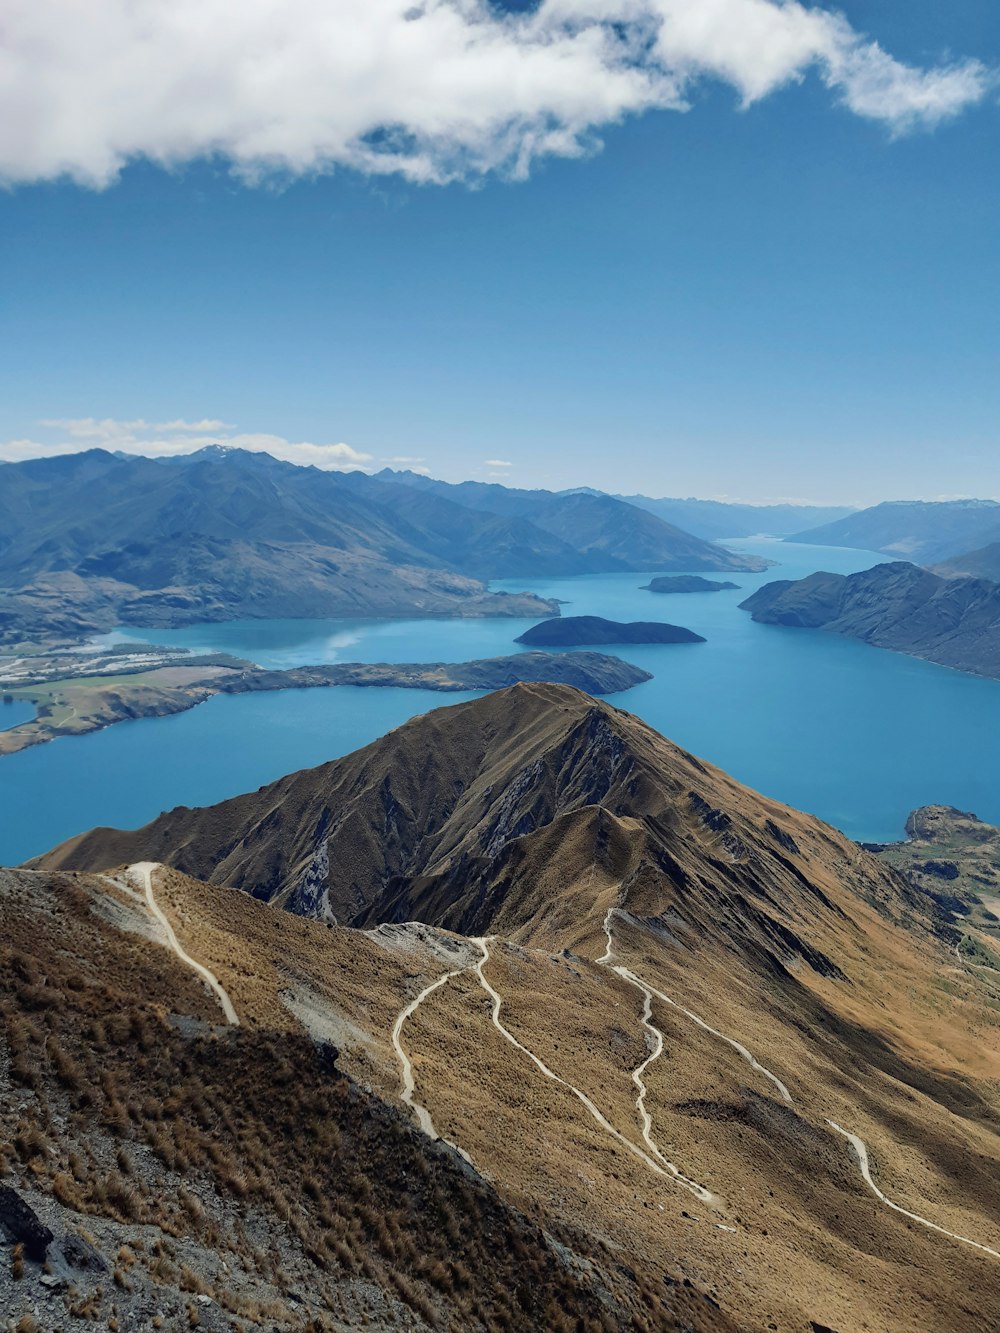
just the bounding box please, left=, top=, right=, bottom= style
left=0, top=0, right=992, bottom=185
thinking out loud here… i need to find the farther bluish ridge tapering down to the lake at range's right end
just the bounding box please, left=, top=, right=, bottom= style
left=373, top=469, right=767, bottom=572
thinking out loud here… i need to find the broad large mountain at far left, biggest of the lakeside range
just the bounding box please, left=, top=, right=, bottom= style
left=0, top=451, right=565, bottom=641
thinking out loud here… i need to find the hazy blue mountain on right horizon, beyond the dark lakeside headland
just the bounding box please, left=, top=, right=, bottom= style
left=788, top=500, right=1000, bottom=565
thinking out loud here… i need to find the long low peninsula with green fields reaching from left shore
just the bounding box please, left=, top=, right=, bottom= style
left=0, top=647, right=652, bottom=756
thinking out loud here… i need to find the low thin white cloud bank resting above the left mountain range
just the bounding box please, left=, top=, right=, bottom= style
left=0, top=417, right=372, bottom=472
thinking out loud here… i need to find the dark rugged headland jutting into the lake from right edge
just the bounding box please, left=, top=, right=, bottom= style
left=740, top=563, right=1000, bottom=678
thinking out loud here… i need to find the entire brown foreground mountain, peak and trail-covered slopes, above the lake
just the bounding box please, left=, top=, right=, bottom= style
left=25, top=684, right=1000, bottom=1333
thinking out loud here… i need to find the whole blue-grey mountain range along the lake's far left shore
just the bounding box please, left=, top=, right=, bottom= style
left=0, top=448, right=764, bottom=643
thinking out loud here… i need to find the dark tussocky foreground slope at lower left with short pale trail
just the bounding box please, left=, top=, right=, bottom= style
left=0, top=868, right=714, bottom=1333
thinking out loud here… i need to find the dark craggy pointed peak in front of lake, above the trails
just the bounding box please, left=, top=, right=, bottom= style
left=32, top=684, right=928, bottom=959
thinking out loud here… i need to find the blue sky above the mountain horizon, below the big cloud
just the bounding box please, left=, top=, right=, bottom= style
left=0, top=0, right=1000, bottom=503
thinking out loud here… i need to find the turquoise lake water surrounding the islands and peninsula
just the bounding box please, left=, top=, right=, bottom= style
left=0, top=539, right=1000, bottom=864
